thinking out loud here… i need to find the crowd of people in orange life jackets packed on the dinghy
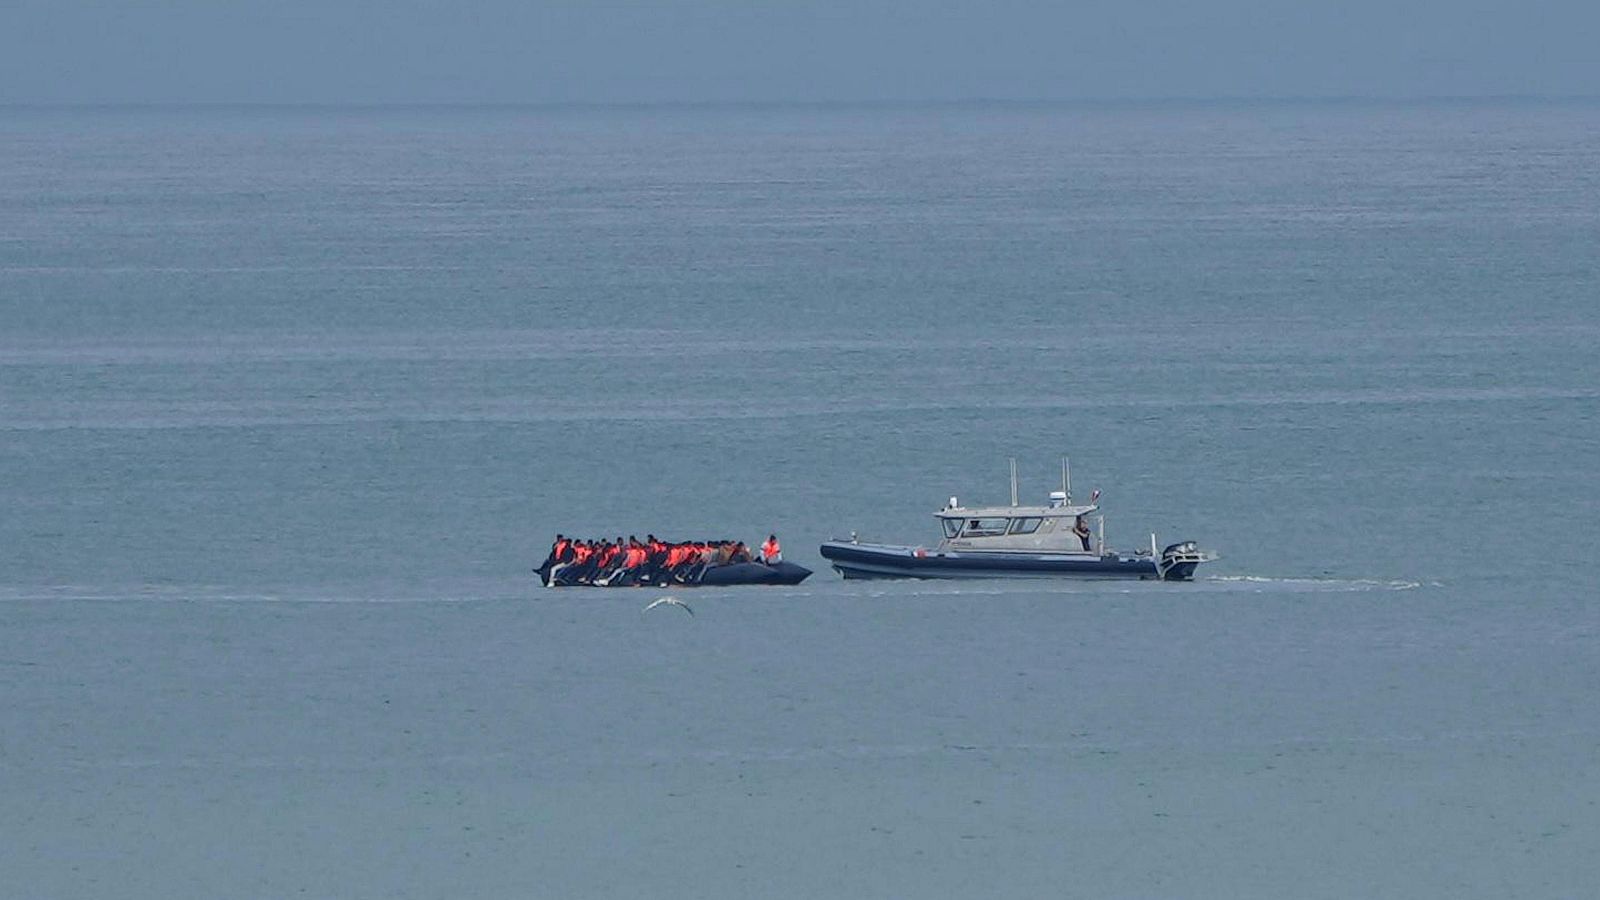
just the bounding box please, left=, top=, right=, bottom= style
left=536, top=535, right=784, bottom=588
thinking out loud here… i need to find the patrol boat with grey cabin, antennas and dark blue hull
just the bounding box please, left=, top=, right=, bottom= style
left=821, top=460, right=1216, bottom=581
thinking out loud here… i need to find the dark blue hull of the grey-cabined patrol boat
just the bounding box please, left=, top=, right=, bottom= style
left=821, top=541, right=1195, bottom=581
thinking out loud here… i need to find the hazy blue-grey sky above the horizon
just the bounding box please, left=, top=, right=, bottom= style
left=0, top=0, right=1600, bottom=102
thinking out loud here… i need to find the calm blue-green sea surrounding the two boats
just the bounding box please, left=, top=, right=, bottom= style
left=0, top=99, right=1600, bottom=900
